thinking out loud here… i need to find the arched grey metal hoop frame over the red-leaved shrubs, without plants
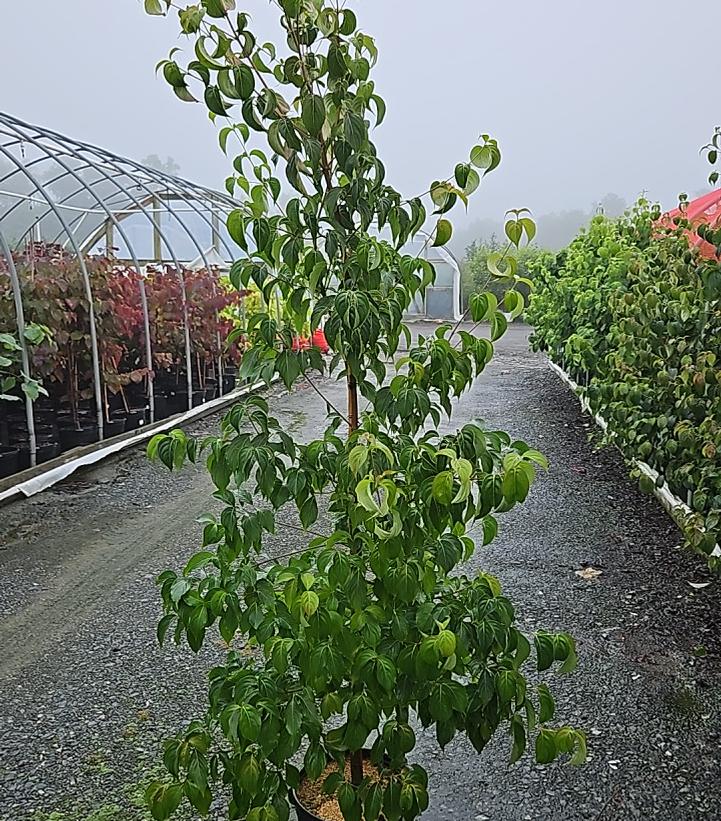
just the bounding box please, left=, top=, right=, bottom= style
left=0, top=112, right=238, bottom=465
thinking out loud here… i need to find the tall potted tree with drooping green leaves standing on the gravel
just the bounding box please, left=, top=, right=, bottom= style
left=146, top=0, right=585, bottom=821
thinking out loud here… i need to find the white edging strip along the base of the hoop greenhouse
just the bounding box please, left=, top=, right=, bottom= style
left=0, top=376, right=279, bottom=503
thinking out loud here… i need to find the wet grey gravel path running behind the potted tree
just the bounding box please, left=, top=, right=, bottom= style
left=0, top=327, right=721, bottom=821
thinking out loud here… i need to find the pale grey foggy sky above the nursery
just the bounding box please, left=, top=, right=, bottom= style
left=0, top=0, right=721, bottom=248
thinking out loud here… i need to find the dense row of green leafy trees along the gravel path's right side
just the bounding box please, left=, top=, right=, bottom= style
left=528, top=202, right=721, bottom=564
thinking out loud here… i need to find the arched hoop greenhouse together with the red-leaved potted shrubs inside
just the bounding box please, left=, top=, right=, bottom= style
left=0, top=114, right=243, bottom=477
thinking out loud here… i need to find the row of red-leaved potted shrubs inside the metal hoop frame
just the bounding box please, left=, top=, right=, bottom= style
left=0, top=244, right=247, bottom=478
